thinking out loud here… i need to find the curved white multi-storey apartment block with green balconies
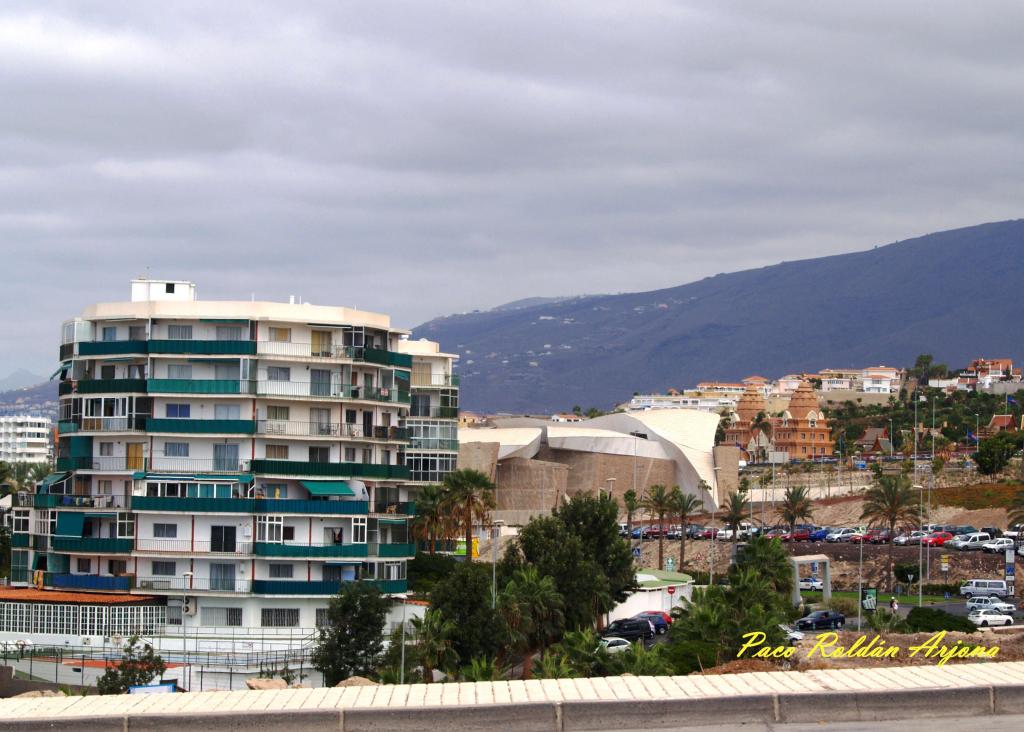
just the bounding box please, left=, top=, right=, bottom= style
left=9, top=279, right=459, bottom=630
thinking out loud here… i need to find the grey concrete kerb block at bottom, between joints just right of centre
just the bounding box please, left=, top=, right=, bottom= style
left=562, top=694, right=775, bottom=732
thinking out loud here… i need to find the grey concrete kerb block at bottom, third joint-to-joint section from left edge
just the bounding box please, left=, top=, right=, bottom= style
left=344, top=702, right=559, bottom=732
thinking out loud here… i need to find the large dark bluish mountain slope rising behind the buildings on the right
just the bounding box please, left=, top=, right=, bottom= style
left=413, top=220, right=1024, bottom=413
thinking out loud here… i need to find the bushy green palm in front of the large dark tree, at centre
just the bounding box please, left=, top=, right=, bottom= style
left=498, top=566, right=565, bottom=675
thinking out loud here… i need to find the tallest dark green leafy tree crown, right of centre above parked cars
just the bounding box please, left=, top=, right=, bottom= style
left=554, top=493, right=636, bottom=603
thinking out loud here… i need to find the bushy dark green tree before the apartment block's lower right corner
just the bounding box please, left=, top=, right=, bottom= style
left=312, top=582, right=391, bottom=686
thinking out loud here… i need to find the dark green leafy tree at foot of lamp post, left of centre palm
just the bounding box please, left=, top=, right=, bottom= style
left=430, top=562, right=508, bottom=658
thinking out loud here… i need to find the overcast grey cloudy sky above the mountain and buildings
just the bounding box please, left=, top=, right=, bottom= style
left=0, top=0, right=1024, bottom=376
